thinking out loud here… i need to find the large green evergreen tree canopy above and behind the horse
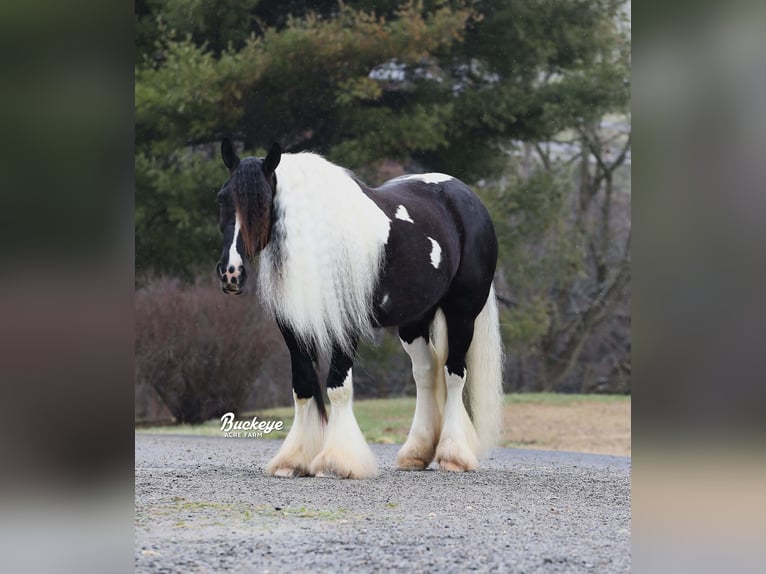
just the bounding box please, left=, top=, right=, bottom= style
left=136, top=0, right=628, bottom=276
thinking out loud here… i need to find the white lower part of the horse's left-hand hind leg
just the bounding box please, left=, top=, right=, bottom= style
left=396, top=337, right=441, bottom=470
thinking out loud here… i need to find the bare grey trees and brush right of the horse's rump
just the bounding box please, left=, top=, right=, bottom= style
left=482, top=120, right=631, bottom=392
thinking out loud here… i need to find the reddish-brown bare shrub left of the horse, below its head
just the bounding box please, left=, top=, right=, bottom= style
left=135, top=278, right=290, bottom=423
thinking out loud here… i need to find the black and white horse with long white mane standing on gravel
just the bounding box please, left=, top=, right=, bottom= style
left=217, top=139, right=503, bottom=478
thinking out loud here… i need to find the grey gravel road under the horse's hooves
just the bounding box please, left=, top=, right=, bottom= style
left=135, top=434, right=631, bottom=573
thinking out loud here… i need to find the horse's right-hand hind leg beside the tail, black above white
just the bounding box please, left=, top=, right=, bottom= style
left=435, top=302, right=479, bottom=471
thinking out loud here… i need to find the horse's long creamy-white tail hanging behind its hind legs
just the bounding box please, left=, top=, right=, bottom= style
left=466, top=285, right=503, bottom=456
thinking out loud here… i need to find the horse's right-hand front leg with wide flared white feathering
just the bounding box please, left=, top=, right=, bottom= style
left=310, top=345, right=378, bottom=478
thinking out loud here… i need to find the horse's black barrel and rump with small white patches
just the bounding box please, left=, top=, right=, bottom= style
left=368, top=174, right=497, bottom=325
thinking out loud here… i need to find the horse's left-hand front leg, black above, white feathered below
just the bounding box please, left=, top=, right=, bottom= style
left=266, top=324, right=327, bottom=476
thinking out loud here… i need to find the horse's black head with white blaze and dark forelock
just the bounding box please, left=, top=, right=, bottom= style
left=217, top=139, right=282, bottom=295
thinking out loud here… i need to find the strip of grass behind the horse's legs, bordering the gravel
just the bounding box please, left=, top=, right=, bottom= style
left=136, top=393, right=631, bottom=456
